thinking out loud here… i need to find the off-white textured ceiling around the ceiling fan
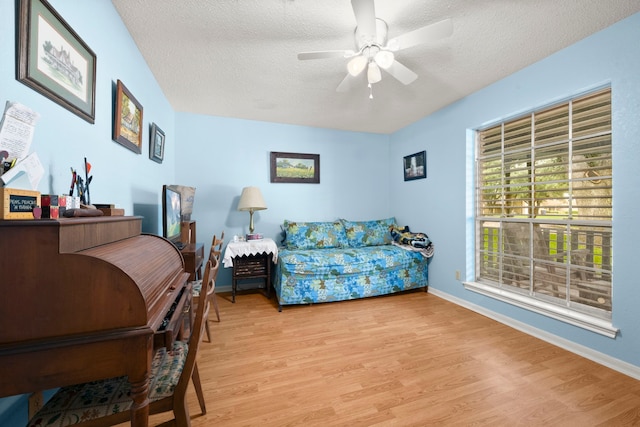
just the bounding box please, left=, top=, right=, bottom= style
left=112, top=0, right=640, bottom=133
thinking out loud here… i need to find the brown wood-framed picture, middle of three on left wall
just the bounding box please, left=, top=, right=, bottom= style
left=113, top=80, right=142, bottom=154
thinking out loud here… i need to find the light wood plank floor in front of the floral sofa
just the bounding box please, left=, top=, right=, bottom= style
left=132, top=291, right=640, bottom=427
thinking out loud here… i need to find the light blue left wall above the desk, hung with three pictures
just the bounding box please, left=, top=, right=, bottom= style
left=0, top=0, right=175, bottom=232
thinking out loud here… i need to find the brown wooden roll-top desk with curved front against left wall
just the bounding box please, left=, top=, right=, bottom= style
left=0, top=217, right=191, bottom=426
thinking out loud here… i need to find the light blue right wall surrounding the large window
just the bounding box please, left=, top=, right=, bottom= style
left=389, top=14, right=640, bottom=366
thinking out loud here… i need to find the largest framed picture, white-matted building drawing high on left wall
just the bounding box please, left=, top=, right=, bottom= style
left=16, top=0, right=96, bottom=123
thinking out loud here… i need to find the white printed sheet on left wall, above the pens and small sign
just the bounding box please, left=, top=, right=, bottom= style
left=0, top=101, right=40, bottom=160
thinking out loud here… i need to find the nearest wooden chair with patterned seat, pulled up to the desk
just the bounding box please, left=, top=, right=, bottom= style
left=28, top=262, right=214, bottom=427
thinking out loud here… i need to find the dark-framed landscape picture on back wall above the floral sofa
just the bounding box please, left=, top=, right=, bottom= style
left=271, top=151, right=320, bottom=184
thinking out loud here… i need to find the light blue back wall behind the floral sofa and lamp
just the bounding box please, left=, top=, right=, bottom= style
left=176, top=113, right=390, bottom=286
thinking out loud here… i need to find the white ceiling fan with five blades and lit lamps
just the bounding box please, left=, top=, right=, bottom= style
left=298, top=0, right=453, bottom=98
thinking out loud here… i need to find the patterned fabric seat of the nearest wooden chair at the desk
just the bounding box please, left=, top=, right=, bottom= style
left=29, top=341, right=189, bottom=427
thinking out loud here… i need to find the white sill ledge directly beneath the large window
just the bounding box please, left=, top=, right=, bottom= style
left=463, top=282, right=618, bottom=338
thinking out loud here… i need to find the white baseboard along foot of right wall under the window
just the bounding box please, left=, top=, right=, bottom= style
left=429, top=283, right=640, bottom=380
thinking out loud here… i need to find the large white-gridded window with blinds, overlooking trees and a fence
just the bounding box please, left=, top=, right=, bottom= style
left=475, top=88, right=613, bottom=319
